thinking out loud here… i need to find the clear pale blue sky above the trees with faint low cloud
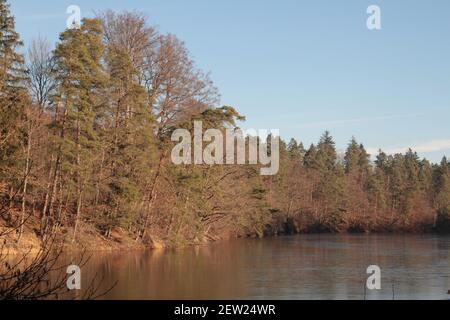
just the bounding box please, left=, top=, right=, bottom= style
left=10, top=0, right=450, bottom=161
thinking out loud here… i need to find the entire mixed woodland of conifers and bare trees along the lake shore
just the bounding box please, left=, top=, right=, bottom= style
left=0, top=0, right=450, bottom=250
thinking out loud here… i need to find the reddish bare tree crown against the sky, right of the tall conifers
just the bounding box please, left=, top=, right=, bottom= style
left=143, top=34, right=219, bottom=137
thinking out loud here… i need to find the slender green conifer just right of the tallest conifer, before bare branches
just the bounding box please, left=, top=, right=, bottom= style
left=101, top=47, right=155, bottom=237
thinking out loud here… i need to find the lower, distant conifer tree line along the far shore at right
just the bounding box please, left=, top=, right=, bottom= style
left=267, top=132, right=450, bottom=232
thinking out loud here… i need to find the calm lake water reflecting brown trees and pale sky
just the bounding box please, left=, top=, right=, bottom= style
left=67, top=235, right=450, bottom=300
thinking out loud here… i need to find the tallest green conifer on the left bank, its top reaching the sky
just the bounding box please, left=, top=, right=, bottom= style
left=50, top=19, right=107, bottom=238
